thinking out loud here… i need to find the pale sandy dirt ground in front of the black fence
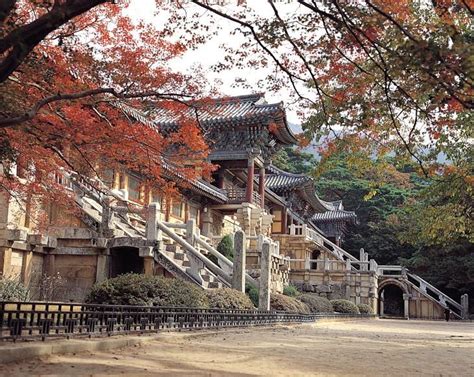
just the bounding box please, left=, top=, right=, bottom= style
left=0, top=320, right=474, bottom=376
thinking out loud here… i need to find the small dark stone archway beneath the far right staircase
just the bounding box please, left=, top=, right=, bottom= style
left=378, top=279, right=409, bottom=318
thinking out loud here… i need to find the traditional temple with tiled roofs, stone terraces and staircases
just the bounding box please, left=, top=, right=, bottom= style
left=0, top=94, right=467, bottom=318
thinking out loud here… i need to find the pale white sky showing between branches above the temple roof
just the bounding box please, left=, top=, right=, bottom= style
left=129, top=0, right=308, bottom=125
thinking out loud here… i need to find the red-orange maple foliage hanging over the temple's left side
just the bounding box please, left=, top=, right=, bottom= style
left=0, top=0, right=214, bottom=223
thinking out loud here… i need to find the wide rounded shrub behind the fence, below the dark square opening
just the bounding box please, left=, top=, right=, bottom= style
left=86, top=274, right=209, bottom=308
